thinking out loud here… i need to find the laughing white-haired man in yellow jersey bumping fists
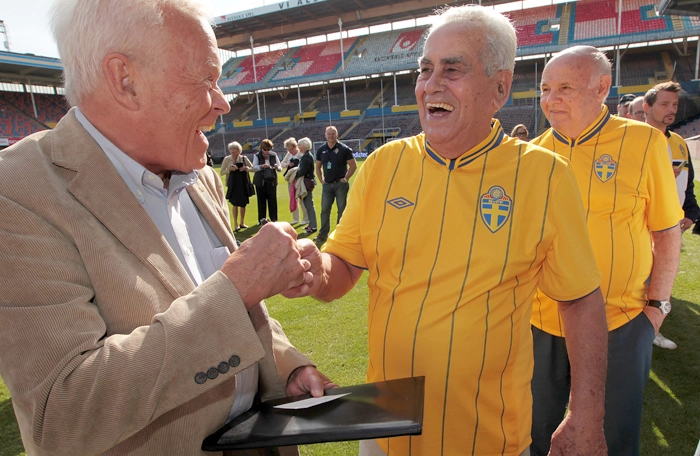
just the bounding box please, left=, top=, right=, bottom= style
left=288, top=5, right=607, bottom=456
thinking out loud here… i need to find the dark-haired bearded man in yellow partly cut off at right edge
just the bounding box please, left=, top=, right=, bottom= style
left=643, top=82, right=700, bottom=350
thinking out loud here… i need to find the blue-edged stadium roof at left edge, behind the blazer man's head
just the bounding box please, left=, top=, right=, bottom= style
left=0, top=51, right=63, bottom=87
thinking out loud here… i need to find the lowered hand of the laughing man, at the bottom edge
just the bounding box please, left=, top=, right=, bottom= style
left=549, top=411, right=608, bottom=456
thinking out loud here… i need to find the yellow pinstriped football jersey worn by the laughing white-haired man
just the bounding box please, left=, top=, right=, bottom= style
left=324, top=121, right=600, bottom=456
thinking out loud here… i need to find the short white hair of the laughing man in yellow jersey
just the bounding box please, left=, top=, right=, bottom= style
left=426, top=5, right=518, bottom=77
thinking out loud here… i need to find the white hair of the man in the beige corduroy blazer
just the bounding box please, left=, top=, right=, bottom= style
left=49, top=0, right=212, bottom=106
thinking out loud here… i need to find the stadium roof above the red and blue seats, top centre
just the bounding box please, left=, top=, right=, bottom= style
left=214, top=0, right=512, bottom=51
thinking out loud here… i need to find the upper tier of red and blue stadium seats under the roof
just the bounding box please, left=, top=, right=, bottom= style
left=216, top=0, right=700, bottom=93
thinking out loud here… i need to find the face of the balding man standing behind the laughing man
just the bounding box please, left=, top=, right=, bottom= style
left=540, top=54, right=610, bottom=139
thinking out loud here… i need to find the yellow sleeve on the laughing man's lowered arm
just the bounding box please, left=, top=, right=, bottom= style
left=539, top=166, right=601, bottom=301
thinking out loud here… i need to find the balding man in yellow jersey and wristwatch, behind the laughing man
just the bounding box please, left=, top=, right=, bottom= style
left=532, top=46, right=683, bottom=456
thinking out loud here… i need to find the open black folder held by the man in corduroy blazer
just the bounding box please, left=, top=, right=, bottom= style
left=202, top=377, right=425, bottom=451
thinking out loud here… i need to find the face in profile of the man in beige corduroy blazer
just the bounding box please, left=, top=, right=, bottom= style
left=136, top=12, right=230, bottom=173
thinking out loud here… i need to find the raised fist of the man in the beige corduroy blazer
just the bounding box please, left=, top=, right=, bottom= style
left=221, top=223, right=313, bottom=309
